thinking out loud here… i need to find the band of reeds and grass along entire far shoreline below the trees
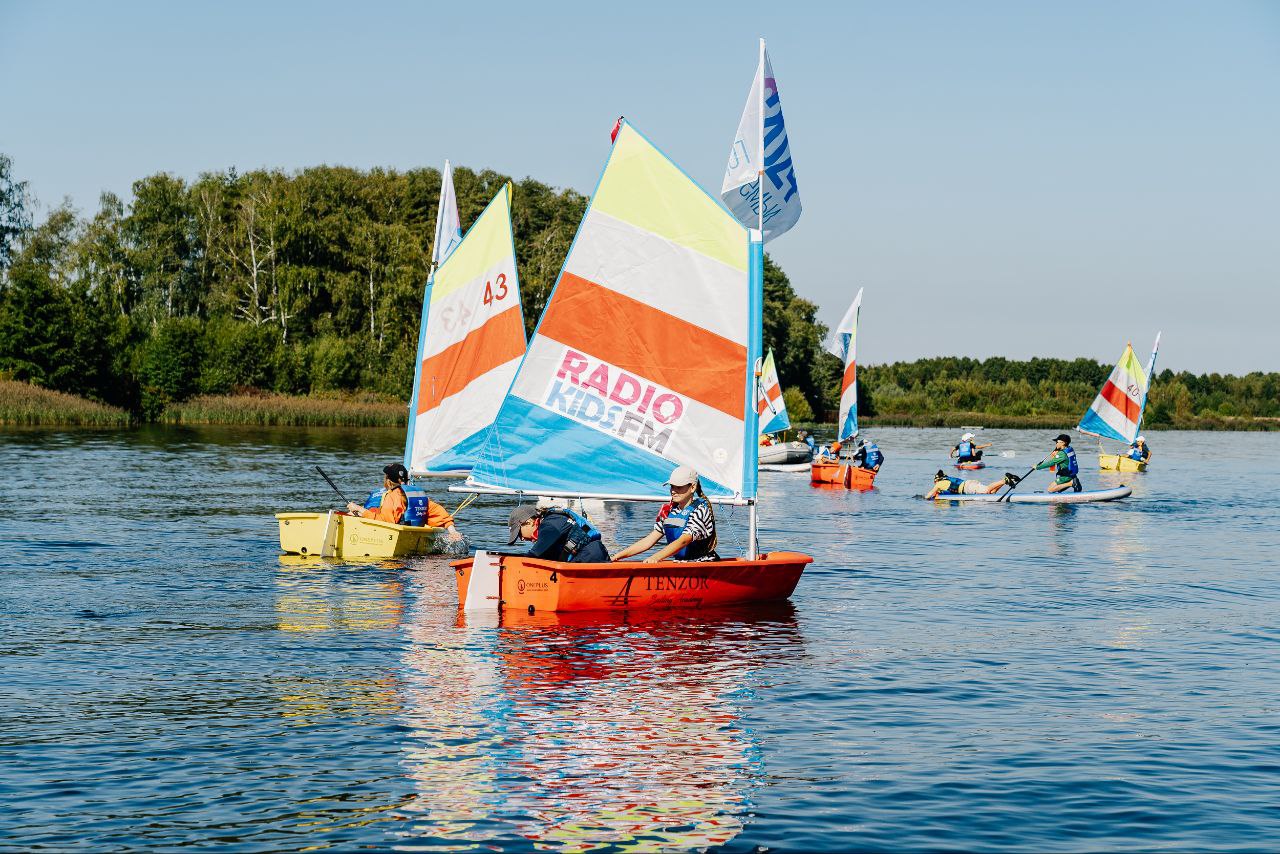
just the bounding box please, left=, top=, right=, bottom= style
left=0, top=379, right=1280, bottom=433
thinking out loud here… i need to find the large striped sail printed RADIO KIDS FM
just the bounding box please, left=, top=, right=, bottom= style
left=471, top=122, right=763, bottom=499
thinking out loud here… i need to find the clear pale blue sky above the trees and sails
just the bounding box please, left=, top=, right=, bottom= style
left=0, top=0, right=1280, bottom=373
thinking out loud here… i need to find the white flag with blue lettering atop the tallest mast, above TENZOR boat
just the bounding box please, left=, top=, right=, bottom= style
left=721, top=38, right=800, bottom=241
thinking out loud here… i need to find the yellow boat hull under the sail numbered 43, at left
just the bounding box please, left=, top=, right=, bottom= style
left=275, top=512, right=442, bottom=558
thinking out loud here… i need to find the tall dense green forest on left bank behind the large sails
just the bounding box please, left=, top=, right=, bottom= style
left=0, top=155, right=831, bottom=419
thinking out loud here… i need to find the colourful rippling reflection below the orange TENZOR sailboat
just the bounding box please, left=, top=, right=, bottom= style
left=402, top=591, right=803, bottom=850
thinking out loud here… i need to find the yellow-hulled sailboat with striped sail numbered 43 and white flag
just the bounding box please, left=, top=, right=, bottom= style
left=276, top=174, right=525, bottom=558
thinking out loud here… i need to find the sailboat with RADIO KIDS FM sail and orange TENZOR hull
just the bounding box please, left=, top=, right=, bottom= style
left=451, top=120, right=813, bottom=612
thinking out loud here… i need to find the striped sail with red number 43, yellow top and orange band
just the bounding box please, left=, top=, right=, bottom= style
left=404, top=184, right=525, bottom=475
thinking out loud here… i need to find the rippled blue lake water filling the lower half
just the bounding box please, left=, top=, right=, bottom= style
left=0, top=428, right=1280, bottom=851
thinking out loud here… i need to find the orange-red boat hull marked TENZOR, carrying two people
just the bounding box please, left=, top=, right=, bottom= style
left=452, top=552, right=813, bottom=613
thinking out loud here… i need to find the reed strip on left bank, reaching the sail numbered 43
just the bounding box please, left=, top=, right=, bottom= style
left=160, top=393, right=408, bottom=428
